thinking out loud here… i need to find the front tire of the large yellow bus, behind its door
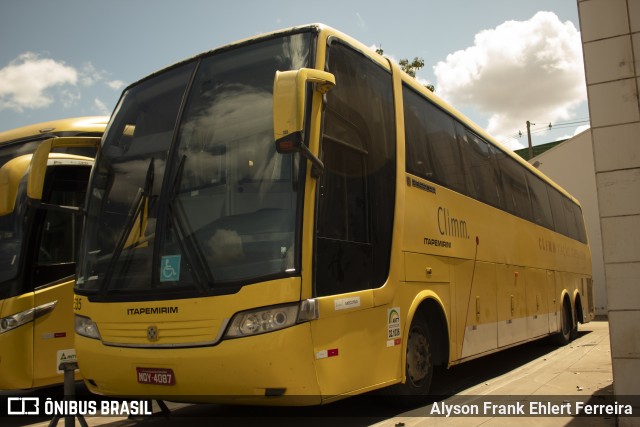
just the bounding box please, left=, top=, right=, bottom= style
left=389, top=317, right=433, bottom=406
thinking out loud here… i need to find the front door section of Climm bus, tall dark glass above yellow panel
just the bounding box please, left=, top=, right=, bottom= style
left=311, top=40, right=402, bottom=396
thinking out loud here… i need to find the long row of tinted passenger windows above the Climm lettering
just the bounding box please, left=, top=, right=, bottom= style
left=403, top=80, right=587, bottom=243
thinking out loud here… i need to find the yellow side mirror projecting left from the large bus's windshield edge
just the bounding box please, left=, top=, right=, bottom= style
left=27, top=136, right=101, bottom=211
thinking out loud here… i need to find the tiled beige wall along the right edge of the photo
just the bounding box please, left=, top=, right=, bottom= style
left=577, top=0, right=640, bottom=425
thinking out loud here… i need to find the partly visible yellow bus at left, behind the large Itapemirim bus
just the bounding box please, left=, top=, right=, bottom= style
left=0, top=117, right=109, bottom=390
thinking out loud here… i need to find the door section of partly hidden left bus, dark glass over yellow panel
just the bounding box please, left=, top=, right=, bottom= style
left=28, top=159, right=92, bottom=387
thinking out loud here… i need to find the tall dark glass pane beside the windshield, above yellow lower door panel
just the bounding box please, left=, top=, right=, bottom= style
left=314, top=41, right=395, bottom=296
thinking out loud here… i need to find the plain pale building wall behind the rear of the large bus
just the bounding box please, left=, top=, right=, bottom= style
left=519, top=130, right=607, bottom=315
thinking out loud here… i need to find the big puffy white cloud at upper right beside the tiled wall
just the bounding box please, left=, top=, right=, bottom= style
left=434, top=12, right=587, bottom=140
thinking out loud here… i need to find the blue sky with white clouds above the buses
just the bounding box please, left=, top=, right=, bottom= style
left=0, top=0, right=588, bottom=148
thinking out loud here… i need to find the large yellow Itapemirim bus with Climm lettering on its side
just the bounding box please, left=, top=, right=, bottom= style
left=62, top=25, right=593, bottom=405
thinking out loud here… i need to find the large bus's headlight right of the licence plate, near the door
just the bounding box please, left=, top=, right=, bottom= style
left=225, top=303, right=300, bottom=338
